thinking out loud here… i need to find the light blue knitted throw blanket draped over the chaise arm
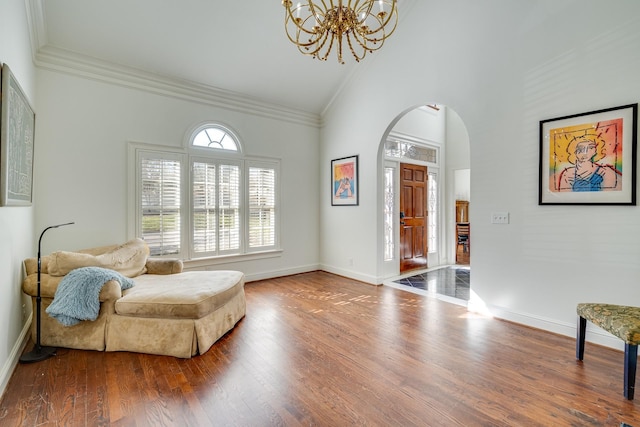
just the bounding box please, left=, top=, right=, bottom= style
left=46, top=267, right=133, bottom=326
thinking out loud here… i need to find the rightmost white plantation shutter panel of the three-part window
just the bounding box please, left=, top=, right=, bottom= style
left=249, top=167, right=276, bottom=248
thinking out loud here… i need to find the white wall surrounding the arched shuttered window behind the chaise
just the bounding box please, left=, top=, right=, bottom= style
left=35, top=69, right=320, bottom=280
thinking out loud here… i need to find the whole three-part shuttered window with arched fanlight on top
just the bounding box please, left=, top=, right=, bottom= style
left=130, top=125, right=280, bottom=260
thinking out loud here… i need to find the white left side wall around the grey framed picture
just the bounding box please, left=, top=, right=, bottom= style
left=0, top=0, right=39, bottom=395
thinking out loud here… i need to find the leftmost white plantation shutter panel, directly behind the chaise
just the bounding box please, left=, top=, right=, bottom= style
left=138, top=153, right=182, bottom=256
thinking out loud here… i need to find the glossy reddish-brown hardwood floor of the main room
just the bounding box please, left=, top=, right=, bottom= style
left=0, top=272, right=640, bottom=426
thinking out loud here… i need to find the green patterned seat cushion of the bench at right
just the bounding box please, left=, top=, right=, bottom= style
left=577, top=303, right=640, bottom=345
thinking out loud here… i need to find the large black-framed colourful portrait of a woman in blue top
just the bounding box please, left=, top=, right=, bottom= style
left=538, top=104, right=638, bottom=205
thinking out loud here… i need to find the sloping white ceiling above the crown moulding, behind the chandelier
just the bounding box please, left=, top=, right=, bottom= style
left=32, top=0, right=384, bottom=115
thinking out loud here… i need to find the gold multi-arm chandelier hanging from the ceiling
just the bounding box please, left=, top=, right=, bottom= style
left=282, top=0, right=398, bottom=64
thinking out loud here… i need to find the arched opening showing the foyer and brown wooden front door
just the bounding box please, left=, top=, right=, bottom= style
left=378, top=103, right=470, bottom=279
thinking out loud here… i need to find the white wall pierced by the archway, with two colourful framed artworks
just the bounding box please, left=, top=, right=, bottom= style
left=321, top=0, right=640, bottom=345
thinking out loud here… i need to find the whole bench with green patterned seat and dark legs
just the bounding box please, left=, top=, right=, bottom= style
left=576, top=303, right=640, bottom=400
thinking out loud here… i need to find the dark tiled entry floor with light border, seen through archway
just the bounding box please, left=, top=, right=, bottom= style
left=382, top=265, right=471, bottom=307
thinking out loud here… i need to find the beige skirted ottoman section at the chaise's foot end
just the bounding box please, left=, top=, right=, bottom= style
left=105, top=271, right=246, bottom=358
